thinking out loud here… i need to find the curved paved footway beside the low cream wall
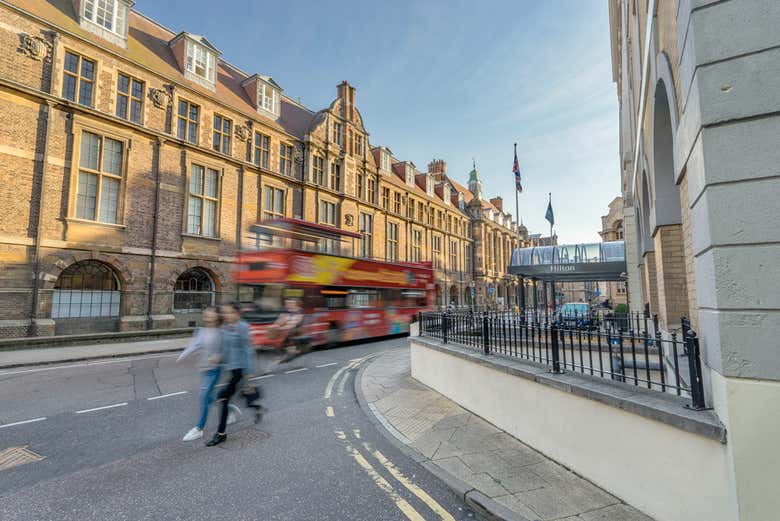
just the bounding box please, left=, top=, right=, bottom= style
left=359, top=347, right=652, bottom=521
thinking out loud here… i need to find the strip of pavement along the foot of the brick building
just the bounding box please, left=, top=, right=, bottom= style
left=0, top=337, right=191, bottom=368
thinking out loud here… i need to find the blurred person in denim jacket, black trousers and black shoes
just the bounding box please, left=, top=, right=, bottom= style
left=206, top=302, right=254, bottom=447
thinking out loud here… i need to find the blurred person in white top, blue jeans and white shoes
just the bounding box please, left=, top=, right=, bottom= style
left=176, top=306, right=222, bottom=441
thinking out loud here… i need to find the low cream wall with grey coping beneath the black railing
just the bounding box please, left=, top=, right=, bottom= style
left=410, top=337, right=738, bottom=521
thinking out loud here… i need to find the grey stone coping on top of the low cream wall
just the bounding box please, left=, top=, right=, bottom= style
left=412, top=337, right=726, bottom=443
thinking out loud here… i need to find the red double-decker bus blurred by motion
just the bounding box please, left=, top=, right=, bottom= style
left=234, top=219, right=434, bottom=348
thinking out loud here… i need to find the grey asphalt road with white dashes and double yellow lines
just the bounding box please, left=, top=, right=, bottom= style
left=0, top=339, right=474, bottom=521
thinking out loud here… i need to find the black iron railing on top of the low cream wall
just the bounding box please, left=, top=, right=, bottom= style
left=419, top=311, right=705, bottom=409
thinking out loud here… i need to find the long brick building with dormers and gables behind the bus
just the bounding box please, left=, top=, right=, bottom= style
left=0, top=0, right=521, bottom=336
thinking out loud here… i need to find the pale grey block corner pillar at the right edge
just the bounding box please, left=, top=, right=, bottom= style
left=675, top=0, right=780, bottom=521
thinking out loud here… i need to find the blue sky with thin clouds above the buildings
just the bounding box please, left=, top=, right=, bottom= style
left=136, top=0, right=620, bottom=242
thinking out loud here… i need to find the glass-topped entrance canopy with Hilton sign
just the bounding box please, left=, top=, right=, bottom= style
left=509, top=241, right=626, bottom=282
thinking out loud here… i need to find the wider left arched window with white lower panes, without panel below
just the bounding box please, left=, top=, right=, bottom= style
left=51, top=260, right=120, bottom=318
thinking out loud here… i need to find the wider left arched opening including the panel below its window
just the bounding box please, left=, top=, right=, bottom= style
left=51, top=260, right=121, bottom=334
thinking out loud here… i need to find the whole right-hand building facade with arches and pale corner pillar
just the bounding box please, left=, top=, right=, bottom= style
left=609, top=0, right=780, bottom=520
